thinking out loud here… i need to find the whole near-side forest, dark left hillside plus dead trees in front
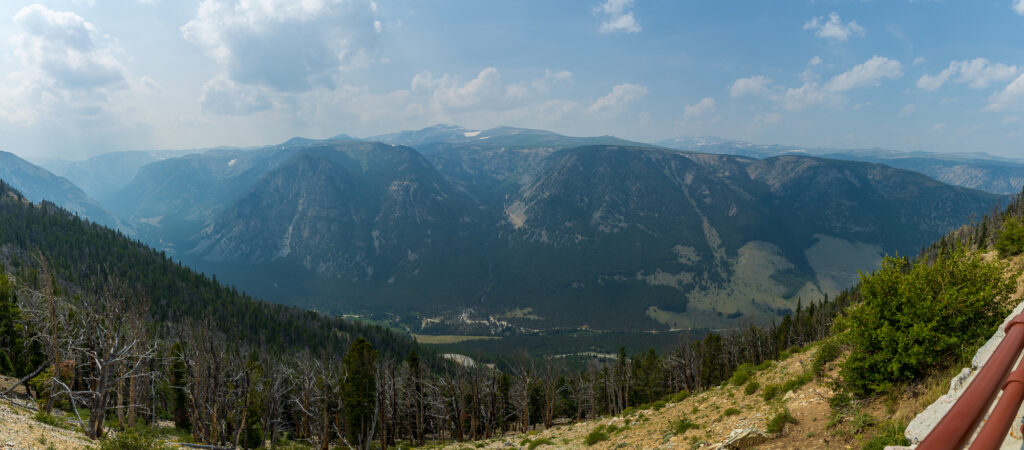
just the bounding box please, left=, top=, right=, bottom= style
left=0, top=178, right=855, bottom=448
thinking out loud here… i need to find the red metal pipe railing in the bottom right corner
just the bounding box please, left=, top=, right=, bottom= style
left=918, top=313, right=1024, bottom=450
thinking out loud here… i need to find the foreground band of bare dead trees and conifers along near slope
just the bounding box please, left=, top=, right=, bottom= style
left=0, top=264, right=854, bottom=449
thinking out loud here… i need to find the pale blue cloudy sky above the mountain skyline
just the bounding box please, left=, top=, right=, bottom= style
left=0, top=0, right=1024, bottom=159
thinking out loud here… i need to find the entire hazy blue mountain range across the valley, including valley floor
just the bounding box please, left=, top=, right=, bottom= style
left=5, top=125, right=1007, bottom=333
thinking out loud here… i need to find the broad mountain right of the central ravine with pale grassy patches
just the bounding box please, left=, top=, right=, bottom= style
left=481, top=147, right=1000, bottom=328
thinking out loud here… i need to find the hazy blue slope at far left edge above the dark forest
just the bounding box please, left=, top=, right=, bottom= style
left=0, top=152, right=122, bottom=229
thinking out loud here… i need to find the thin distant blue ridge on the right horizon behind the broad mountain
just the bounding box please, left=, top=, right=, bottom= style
left=658, top=136, right=1024, bottom=195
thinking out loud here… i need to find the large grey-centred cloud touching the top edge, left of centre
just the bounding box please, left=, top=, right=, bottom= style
left=181, top=0, right=381, bottom=92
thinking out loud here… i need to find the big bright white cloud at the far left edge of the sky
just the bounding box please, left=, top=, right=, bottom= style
left=0, top=4, right=152, bottom=156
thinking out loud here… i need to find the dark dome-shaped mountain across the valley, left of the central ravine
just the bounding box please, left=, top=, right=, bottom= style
left=186, top=144, right=486, bottom=311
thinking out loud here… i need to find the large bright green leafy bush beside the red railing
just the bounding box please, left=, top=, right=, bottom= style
left=842, top=249, right=1016, bottom=396
